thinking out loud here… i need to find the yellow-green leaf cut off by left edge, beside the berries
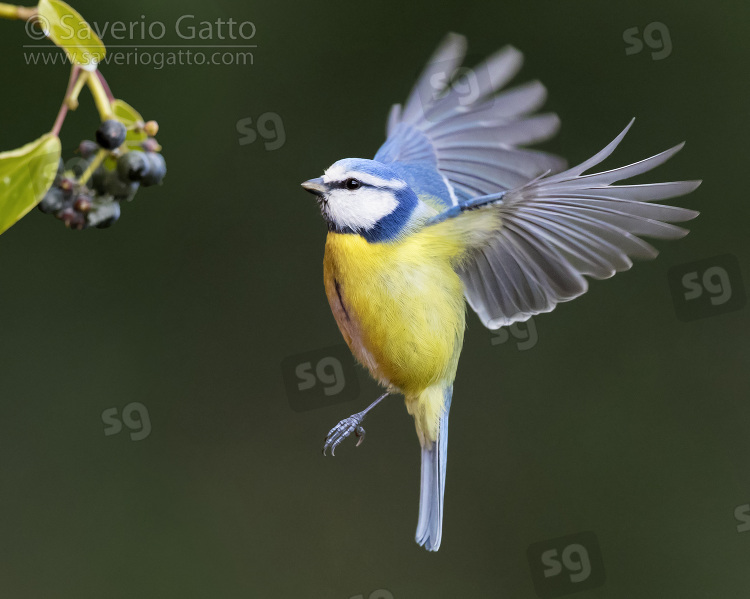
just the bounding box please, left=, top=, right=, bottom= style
left=0, top=133, right=60, bottom=233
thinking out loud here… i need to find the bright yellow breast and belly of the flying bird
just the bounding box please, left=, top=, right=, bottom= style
left=324, top=227, right=465, bottom=396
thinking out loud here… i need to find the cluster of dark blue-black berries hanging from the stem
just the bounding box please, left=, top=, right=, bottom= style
left=38, top=119, right=167, bottom=230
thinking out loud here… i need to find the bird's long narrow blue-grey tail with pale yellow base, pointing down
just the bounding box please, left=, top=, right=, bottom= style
left=407, top=386, right=453, bottom=551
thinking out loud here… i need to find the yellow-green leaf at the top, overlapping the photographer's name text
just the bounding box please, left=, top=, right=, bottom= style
left=37, top=0, right=106, bottom=66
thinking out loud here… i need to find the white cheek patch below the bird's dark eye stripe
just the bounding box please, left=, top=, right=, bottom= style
left=326, top=188, right=398, bottom=231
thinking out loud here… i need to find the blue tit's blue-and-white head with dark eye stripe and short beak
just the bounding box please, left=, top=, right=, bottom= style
left=302, top=158, right=426, bottom=242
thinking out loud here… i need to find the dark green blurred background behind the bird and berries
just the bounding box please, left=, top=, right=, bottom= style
left=0, top=0, right=750, bottom=599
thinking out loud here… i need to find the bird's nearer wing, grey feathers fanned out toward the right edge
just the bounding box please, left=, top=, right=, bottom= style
left=435, top=121, right=701, bottom=329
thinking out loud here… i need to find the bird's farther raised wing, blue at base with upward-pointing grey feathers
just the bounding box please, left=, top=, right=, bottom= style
left=375, top=34, right=565, bottom=206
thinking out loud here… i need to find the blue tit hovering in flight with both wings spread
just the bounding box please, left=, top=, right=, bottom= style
left=302, top=34, right=700, bottom=551
